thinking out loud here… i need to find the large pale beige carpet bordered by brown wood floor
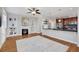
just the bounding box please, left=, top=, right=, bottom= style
left=16, top=36, right=68, bottom=52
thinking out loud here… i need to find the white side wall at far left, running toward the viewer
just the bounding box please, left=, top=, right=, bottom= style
left=0, top=8, right=7, bottom=48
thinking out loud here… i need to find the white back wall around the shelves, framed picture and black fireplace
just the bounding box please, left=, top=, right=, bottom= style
left=7, top=13, right=42, bottom=37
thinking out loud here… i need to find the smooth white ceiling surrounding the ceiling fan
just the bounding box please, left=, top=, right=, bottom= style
left=5, top=7, right=77, bottom=19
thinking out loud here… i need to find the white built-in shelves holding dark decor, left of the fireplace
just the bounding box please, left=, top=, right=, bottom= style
left=8, top=17, right=17, bottom=35
